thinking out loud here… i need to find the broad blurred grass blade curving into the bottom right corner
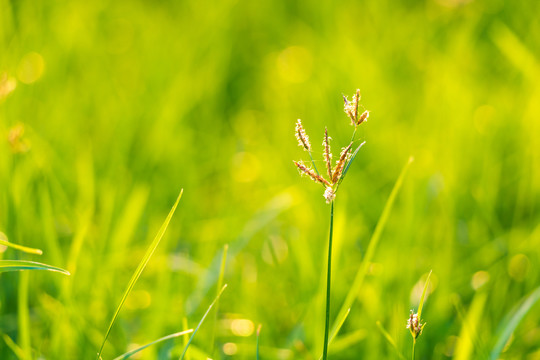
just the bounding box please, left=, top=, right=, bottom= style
left=490, top=287, right=540, bottom=360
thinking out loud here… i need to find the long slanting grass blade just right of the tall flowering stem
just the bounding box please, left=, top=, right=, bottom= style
left=332, top=157, right=413, bottom=334
